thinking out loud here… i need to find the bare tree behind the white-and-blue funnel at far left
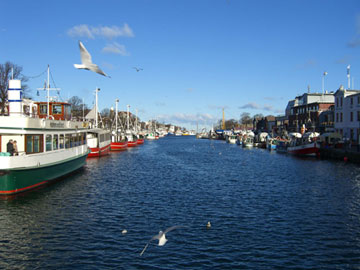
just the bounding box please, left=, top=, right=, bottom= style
left=0, top=62, right=28, bottom=113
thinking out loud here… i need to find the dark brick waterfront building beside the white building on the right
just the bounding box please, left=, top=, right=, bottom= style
left=286, top=92, right=334, bottom=132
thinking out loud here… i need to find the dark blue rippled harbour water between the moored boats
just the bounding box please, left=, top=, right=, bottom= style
left=0, top=137, right=360, bottom=269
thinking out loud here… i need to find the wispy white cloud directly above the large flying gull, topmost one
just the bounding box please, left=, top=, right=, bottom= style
left=67, top=23, right=135, bottom=39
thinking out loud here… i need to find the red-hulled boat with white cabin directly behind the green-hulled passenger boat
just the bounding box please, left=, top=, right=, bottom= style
left=87, top=128, right=111, bottom=157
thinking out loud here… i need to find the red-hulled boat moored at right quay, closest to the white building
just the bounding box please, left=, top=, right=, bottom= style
left=287, top=132, right=320, bottom=156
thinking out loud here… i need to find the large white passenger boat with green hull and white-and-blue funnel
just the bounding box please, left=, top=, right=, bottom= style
left=0, top=77, right=89, bottom=195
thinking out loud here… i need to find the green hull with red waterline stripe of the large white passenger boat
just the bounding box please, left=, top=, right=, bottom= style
left=0, top=154, right=87, bottom=195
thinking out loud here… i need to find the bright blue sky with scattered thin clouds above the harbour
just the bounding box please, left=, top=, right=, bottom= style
left=0, top=0, right=360, bottom=129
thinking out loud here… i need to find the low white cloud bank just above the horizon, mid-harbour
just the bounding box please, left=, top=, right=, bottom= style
left=157, top=113, right=216, bottom=125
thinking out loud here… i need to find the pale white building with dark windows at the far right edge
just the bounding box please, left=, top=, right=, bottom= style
left=335, top=86, right=360, bottom=143
